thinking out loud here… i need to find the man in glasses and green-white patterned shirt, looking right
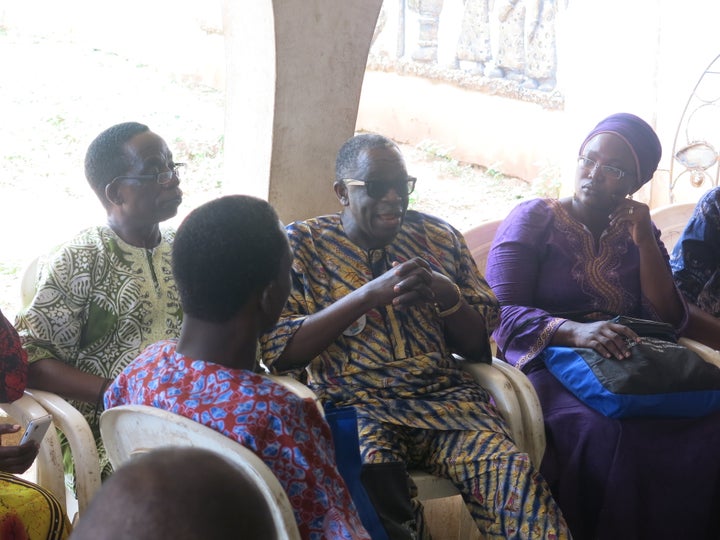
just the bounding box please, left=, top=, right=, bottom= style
left=16, top=122, right=182, bottom=474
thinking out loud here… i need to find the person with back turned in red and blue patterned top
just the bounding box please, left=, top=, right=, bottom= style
left=105, top=195, right=369, bottom=540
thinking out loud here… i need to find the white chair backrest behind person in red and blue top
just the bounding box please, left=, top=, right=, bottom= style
left=100, top=405, right=300, bottom=540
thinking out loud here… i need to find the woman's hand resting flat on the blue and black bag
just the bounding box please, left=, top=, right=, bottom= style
left=551, top=321, right=640, bottom=360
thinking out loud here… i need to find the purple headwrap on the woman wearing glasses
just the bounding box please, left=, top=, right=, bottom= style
left=580, top=113, right=662, bottom=193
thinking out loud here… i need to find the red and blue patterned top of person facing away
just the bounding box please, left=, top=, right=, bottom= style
left=105, top=340, right=370, bottom=540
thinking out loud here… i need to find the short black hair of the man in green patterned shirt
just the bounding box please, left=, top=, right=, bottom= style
left=85, top=122, right=150, bottom=204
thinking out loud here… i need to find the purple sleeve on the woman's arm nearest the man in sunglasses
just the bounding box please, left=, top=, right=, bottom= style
left=486, top=200, right=565, bottom=367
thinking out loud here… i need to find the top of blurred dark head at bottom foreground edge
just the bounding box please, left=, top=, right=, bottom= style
left=70, top=447, right=278, bottom=540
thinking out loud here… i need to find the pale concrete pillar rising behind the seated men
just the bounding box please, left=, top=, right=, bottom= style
left=224, top=0, right=382, bottom=223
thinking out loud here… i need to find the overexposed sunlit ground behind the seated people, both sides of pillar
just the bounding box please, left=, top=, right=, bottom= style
left=0, top=26, right=545, bottom=318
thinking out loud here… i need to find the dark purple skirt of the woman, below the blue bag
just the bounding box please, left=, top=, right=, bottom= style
left=528, top=366, right=720, bottom=540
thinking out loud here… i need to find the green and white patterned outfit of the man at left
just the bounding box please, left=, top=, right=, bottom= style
left=16, top=226, right=182, bottom=472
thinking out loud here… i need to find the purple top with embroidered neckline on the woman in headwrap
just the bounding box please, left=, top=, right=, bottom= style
left=485, top=199, right=680, bottom=367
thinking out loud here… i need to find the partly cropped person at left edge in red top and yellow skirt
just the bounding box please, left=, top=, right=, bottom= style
left=0, top=306, right=71, bottom=540
